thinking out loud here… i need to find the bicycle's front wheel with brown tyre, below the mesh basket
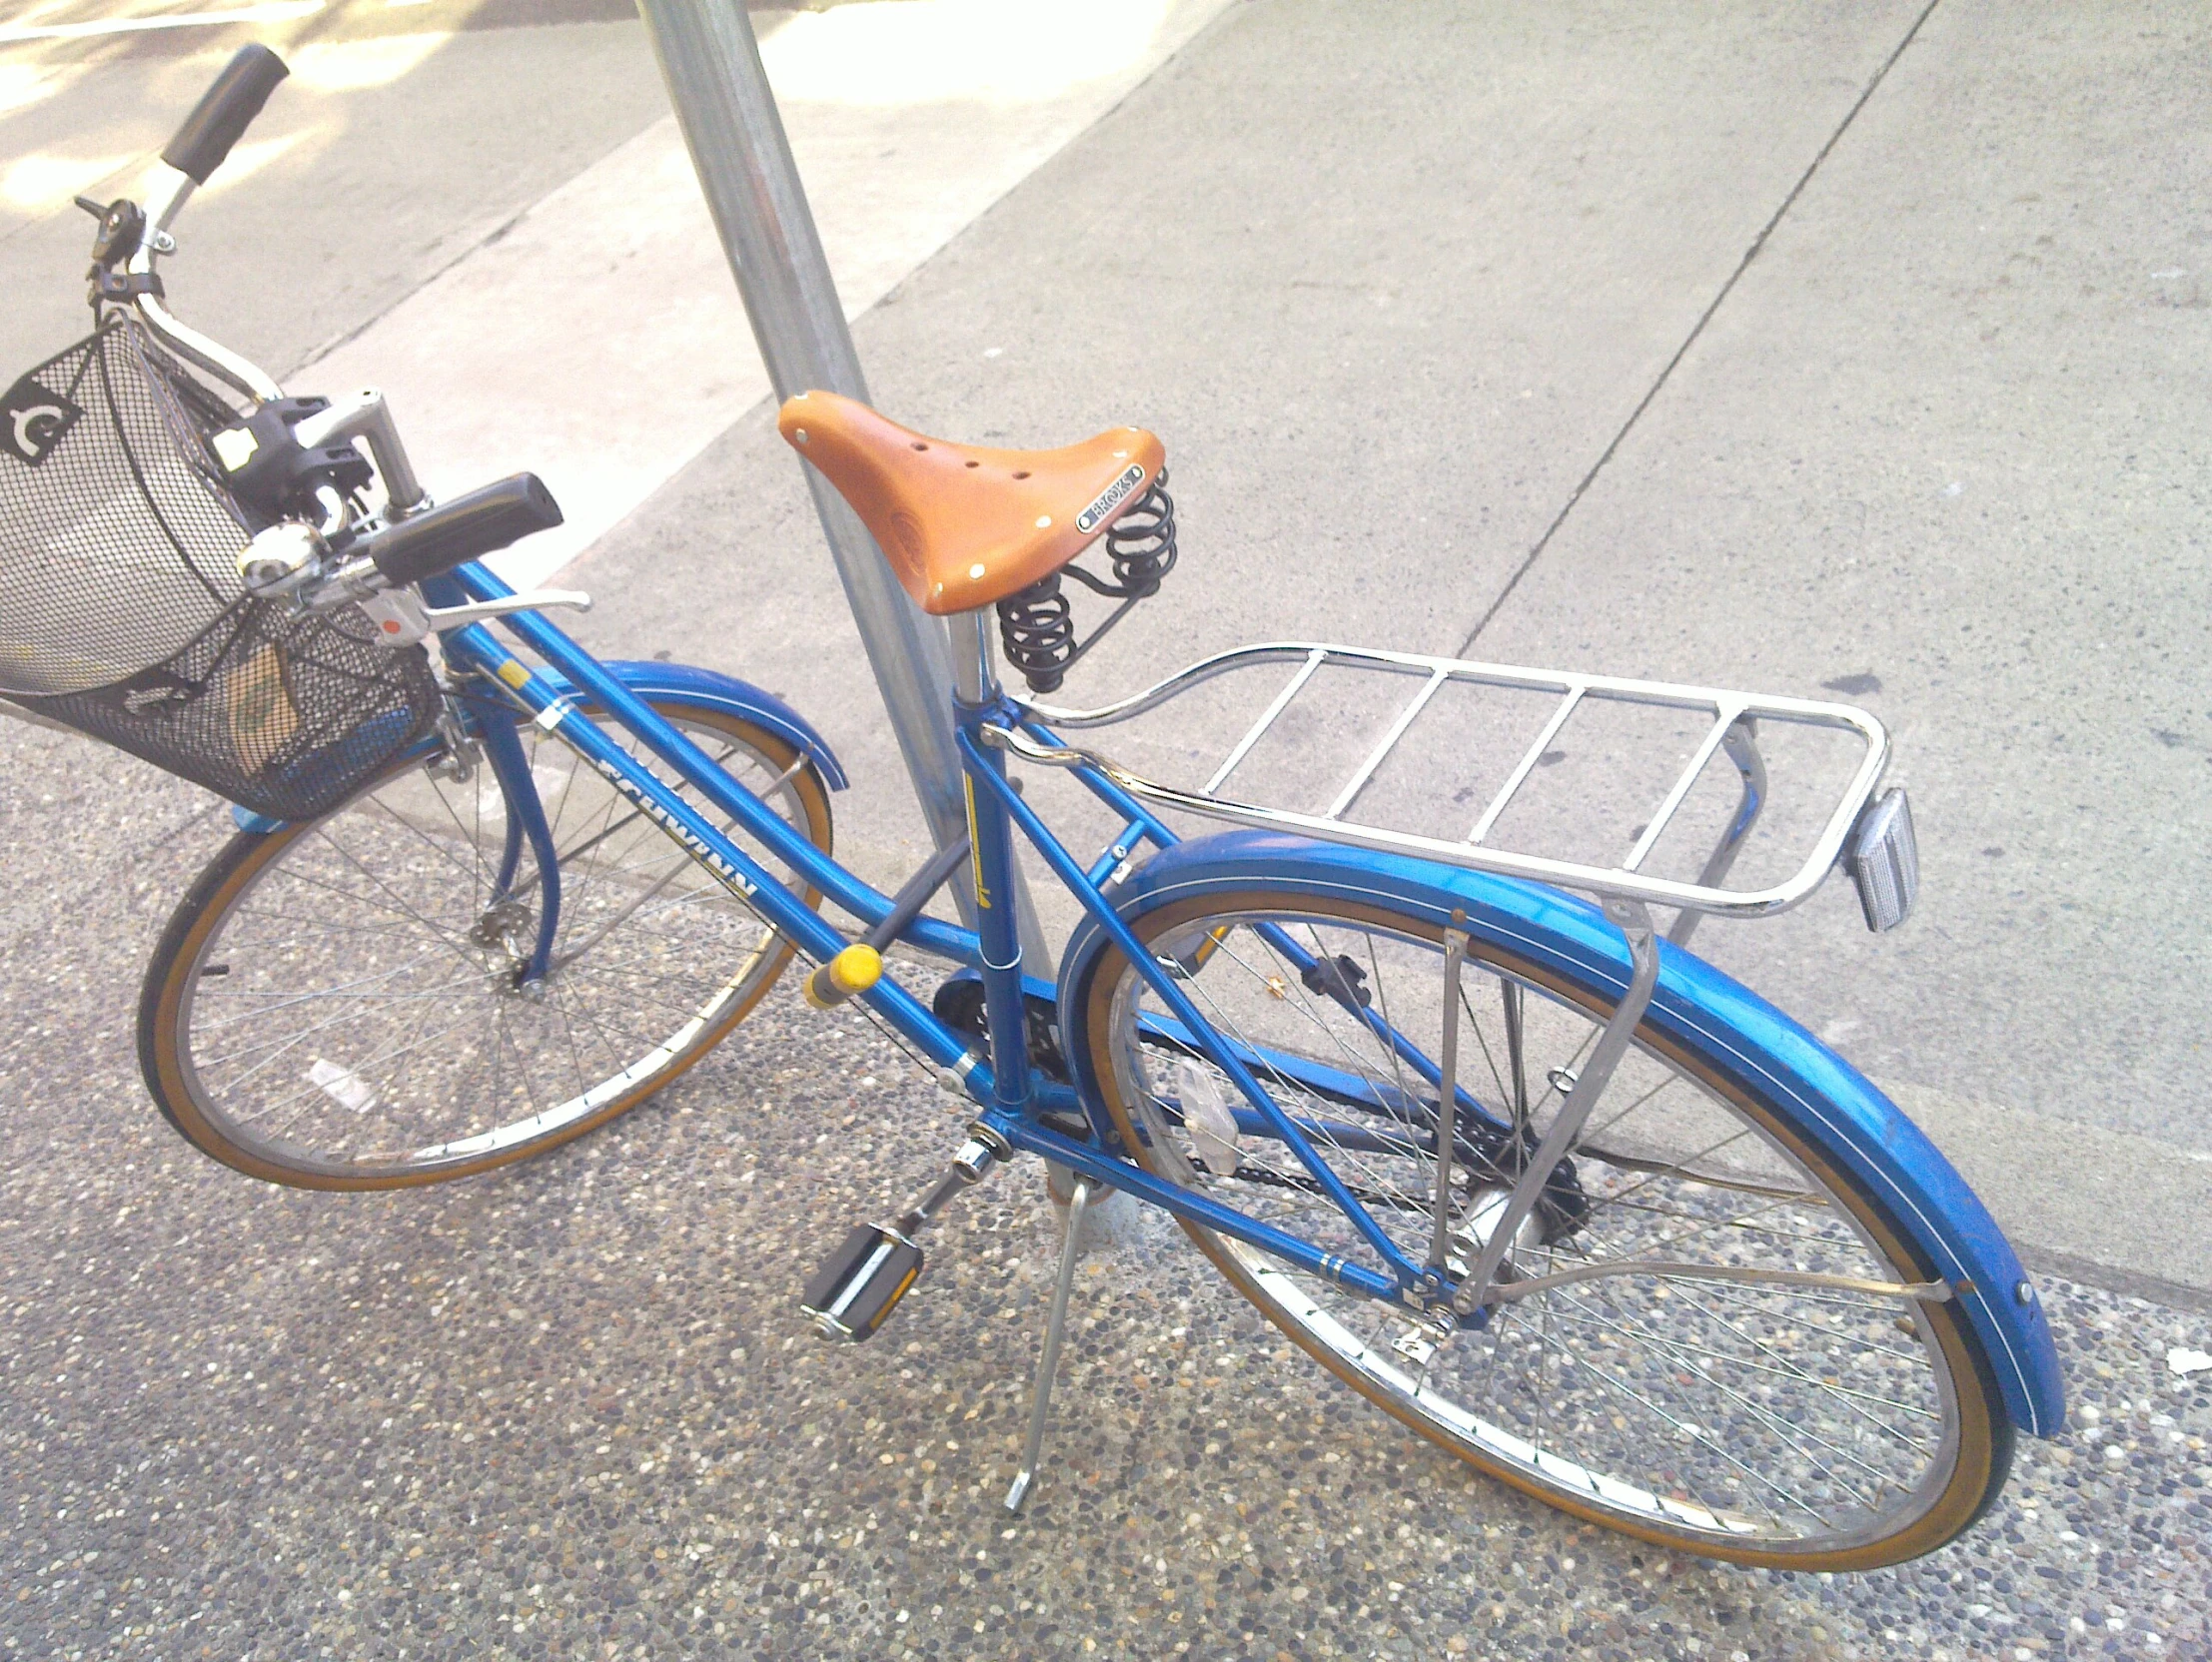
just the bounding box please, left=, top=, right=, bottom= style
left=139, top=700, right=829, bottom=1189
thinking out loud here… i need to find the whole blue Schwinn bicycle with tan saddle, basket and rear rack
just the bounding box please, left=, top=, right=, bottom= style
left=0, top=49, right=2064, bottom=1569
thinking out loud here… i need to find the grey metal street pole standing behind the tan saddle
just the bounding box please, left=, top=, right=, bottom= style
left=637, top=0, right=1053, bottom=959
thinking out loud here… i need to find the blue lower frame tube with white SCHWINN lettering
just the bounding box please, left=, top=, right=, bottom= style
left=445, top=625, right=967, bottom=1068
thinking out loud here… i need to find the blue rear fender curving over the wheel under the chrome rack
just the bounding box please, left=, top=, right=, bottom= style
left=1060, top=831, right=2066, bottom=1436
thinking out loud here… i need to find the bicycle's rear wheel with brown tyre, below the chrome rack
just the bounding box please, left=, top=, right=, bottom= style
left=1079, top=891, right=2011, bottom=1569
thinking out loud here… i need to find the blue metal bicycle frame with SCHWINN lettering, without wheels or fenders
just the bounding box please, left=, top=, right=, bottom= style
left=425, top=565, right=1451, bottom=1306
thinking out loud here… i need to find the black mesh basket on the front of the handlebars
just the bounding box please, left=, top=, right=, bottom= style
left=0, top=316, right=441, bottom=820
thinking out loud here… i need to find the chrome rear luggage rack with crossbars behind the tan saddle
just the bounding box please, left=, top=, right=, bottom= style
left=1013, top=641, right=1918, bottom=942
